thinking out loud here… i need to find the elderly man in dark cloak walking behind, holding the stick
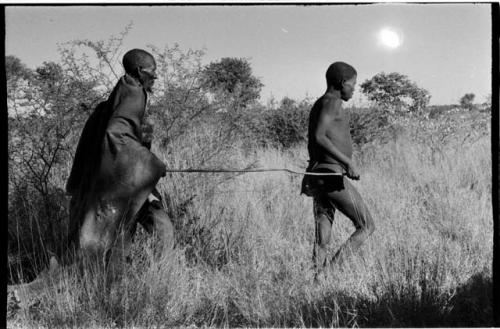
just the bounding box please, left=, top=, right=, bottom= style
left=66, top=49, right=173, bottom=263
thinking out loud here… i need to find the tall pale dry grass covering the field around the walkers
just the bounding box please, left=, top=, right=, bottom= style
left=9, top=114, right=493, bottom=328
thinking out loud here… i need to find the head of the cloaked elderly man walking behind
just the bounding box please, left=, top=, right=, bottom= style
left=123, top=49, right=157, bottom=92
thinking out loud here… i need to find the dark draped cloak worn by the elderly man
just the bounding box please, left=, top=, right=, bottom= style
left=66, top=75, right=165, bottom=254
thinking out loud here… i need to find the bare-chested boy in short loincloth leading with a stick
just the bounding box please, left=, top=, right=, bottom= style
left=302, top=62, right=375, bottom=271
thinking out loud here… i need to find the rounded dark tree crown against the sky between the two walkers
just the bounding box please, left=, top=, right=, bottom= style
left=202, top=57, right=264, bottom=109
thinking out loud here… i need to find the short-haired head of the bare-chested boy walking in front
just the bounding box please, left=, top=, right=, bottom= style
left=326, top=62, right=357, bottom=101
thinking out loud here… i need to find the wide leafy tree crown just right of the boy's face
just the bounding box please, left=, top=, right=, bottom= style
left=361, top=72, right=431, bottom=112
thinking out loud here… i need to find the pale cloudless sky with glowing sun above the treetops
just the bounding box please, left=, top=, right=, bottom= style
left=5, top=4, right=491, bottom=104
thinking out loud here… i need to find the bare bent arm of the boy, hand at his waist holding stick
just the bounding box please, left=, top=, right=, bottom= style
left=314, top=99, right=359, bottom=179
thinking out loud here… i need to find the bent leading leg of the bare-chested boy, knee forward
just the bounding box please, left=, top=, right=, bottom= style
left=328, top=179, right=375, bottom=264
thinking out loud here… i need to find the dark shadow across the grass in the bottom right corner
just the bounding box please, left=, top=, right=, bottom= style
left=296, top=274, right=494, bottom=327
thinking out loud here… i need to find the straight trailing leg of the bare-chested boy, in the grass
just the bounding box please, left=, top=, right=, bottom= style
left=313, top=195, right=335, bottom=272
